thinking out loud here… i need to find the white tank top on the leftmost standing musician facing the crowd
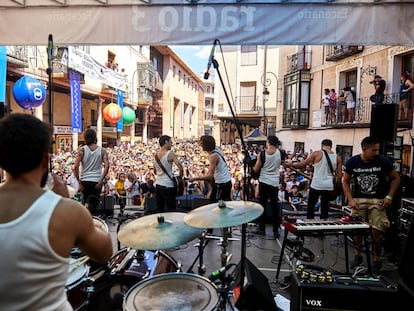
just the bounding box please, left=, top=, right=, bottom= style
left=81, top=146, right=102, bottom=182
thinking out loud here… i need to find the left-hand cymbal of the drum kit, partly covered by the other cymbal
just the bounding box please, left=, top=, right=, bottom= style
left=118, top=212, right=203, bottom=250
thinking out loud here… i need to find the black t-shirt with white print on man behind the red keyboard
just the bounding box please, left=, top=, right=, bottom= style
left=345, top=154, right=394, bottom=199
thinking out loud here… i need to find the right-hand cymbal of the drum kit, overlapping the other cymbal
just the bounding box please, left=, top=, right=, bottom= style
left=184, top=201, right=263, bottom=228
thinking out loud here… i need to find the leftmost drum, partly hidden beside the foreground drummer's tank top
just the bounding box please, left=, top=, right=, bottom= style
left=65, top=258, right=89, bottom=310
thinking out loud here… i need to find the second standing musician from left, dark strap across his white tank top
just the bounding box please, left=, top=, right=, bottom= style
left=153, top=135, right=184, bottom=213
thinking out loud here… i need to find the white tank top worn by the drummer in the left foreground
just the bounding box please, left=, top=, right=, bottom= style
left=0, top=190, right=73, bottom=311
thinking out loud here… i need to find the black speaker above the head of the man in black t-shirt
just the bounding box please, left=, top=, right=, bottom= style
left=370, top=104, right=398, bottom=142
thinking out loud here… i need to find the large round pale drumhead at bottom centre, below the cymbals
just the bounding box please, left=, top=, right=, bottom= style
left=123, top=273, right=219, bottom=311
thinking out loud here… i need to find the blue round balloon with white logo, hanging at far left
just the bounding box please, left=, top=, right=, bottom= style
left=13, top=76, right=46, bottom=109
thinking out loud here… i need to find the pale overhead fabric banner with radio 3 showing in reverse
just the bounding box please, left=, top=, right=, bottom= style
left=0, top=0, right=414, bottom=46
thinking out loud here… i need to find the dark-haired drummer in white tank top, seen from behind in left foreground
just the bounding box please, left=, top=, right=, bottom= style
left=0, top=113, right=112, bottom=311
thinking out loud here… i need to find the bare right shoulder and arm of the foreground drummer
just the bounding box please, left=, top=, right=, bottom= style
left=49, top=198, right=113, bottom=263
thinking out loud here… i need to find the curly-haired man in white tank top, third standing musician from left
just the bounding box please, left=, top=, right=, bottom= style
left=189, top=135, right=232, bottom=237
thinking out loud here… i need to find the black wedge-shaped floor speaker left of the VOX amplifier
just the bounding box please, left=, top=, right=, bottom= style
left=233, top=258, right=278, bottom=311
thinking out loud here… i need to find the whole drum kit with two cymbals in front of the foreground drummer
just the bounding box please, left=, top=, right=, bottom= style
left=66, top=201, right=263, bottom=311
